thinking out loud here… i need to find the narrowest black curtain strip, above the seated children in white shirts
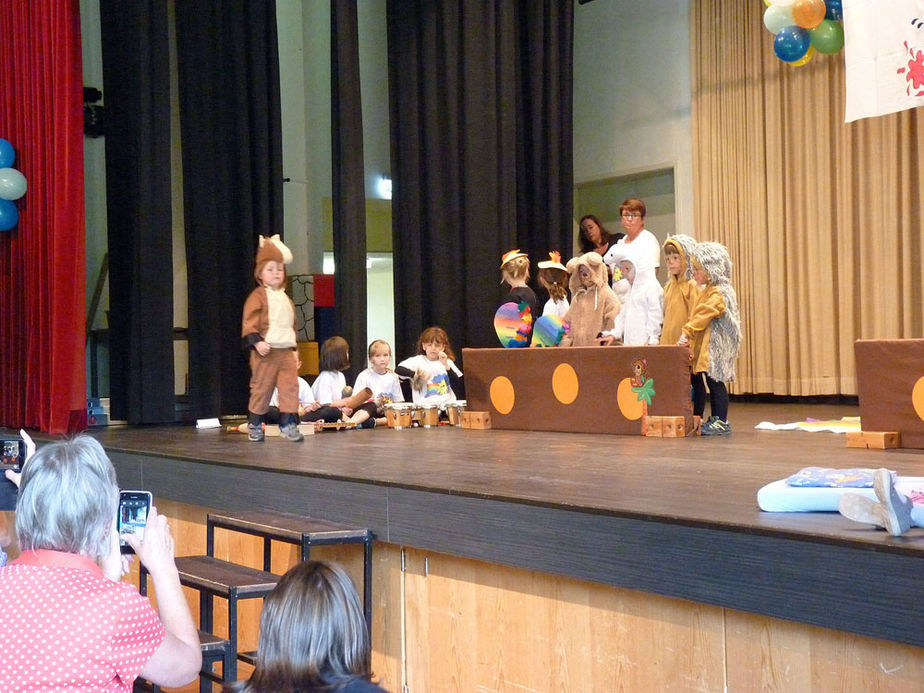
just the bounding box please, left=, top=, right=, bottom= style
left=330, top=0, right=367, bottom=382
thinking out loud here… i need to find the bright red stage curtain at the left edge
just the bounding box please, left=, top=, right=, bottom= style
left=0, top=0, right=86, bottom=433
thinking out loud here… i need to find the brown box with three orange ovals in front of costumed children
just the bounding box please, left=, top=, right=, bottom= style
left=462, top=346, right=693, bottom=435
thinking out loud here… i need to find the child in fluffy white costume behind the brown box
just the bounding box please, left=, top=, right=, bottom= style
left=599, top=250, right=664, bottom=346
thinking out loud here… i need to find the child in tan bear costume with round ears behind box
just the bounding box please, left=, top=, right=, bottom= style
left=561, top=251, right=622, bottom=346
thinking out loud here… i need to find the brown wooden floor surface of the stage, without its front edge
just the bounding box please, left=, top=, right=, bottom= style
left=91, top=403, right=924, bottom=550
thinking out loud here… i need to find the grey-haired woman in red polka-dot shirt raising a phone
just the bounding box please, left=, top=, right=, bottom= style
left=0, top=435, right=202, bottom=691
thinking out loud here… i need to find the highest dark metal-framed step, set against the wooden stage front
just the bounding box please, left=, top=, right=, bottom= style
left=205, top=510, right=375, bottom=636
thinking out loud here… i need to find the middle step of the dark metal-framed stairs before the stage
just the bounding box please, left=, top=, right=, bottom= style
left=139, top=556, right=279, bottom=690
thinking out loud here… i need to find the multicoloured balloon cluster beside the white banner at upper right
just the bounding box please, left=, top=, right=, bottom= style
left=764, top=0, right=844, bottom=66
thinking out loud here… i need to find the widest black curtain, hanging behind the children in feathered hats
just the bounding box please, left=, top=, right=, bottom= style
left=387, top=0, right=573, bottom=357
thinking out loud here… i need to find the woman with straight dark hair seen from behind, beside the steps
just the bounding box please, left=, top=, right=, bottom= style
left=231, top=561, right=385, bottom=693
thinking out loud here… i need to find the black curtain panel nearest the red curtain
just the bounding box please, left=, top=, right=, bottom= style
left=100, top=0, right=176, bottom=424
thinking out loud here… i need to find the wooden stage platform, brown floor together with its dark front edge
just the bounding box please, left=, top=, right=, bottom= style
left=72, top=402, right=924, bottom=646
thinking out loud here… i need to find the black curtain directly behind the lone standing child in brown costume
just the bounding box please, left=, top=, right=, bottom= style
left=176, top=0, right=282, bottom=417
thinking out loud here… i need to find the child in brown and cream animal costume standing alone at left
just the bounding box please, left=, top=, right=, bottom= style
left=241, top=234, right=303, bottom=442
